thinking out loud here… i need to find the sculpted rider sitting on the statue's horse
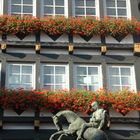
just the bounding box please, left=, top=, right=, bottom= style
left=77, top=102, right=108, bottom=140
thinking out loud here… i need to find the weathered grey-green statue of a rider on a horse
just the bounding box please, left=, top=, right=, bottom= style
left=50, top=102, right=109, bottom=140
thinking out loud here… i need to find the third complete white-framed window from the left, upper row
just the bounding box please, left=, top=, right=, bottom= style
left=74, top=0, right=99, bottom=17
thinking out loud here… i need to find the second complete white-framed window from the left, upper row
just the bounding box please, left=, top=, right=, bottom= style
left=42, top=0, right=68, bottom=16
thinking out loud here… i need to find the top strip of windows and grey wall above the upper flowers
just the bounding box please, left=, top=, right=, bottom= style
left=0, top=0, right=140, bottom=19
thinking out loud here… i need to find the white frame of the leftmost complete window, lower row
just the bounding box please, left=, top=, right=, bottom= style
left=6, top=62, right=36, bottom=90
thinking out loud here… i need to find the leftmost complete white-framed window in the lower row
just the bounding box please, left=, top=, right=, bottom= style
left=7, top=63, right=35, bottom=89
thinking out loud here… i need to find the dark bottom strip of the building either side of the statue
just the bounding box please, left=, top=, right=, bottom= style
left=0, top=129, right=140, bottom=140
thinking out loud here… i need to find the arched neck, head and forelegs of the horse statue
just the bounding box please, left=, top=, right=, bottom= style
left=50, top=110, right=86, bottom=140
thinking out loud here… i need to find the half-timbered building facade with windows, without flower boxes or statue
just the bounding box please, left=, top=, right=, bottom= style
left=0, top=0, right=140, bottom=140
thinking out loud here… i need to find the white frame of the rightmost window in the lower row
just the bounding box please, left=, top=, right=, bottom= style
left=107, top=65, right=136, bottom=91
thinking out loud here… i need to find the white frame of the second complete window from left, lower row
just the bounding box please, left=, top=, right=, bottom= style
left=41, top=64, right=69, bottom=91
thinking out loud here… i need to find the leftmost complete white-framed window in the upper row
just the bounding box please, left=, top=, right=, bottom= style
left=9, top=0, right=36, bottom=16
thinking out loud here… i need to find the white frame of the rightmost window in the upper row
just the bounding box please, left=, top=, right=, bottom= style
left=104, top=0, right=131, bottom=19
